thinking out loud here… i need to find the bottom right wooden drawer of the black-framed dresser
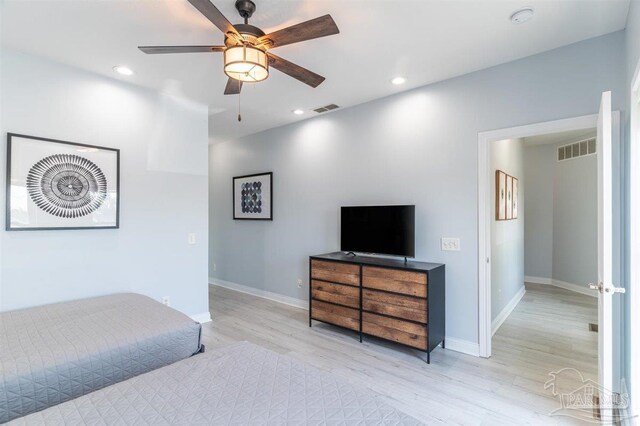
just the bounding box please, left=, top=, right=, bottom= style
left=362, top=312, right=427, bottom=350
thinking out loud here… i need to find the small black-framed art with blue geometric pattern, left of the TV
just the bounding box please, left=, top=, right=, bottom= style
left=233, top=172, right=273, bottom=220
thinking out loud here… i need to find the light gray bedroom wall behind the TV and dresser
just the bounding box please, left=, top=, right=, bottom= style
left=210, top=32, right=626, bottom=342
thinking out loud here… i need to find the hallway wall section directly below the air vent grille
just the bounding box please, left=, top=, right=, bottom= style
left=552, top=150, right=598, bottom=286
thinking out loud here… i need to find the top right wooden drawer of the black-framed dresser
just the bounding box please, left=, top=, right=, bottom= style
left=362, top=266, right=427, bottom=297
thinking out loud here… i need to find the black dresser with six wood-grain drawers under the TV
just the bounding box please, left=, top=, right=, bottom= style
left=309, top=252, right=445, bottom=362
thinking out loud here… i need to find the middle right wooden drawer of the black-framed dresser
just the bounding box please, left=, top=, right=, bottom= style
left=362, top=289, right=427, bottom=323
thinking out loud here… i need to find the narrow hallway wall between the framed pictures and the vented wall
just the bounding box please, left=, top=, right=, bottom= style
left=524, top=145, right=555, bottom=278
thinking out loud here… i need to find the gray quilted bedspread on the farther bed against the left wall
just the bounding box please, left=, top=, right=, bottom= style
left=0, top=294, right=200, bottom=423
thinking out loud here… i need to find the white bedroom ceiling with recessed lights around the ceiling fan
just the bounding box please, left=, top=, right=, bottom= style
left=0, top=0, right=629, bottom=141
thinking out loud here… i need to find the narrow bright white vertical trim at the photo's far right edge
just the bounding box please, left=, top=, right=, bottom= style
left=628, top=61, right=640, bottom=422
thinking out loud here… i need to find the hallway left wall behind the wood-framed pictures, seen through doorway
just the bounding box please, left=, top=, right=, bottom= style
left=490, top=139, right=528, bottom=320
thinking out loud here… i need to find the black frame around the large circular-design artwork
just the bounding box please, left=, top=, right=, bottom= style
left=5, top=132, right=120, bottom=231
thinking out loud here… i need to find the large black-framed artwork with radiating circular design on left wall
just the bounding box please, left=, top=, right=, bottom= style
left=6, top=133, right=120, bottom=231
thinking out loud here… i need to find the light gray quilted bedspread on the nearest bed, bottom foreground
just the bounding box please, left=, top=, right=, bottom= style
left=7, top=342, right=419, bottom=425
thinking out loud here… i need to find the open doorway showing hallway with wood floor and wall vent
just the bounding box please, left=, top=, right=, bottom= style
left=489, top=127, right=598, bottom=392
